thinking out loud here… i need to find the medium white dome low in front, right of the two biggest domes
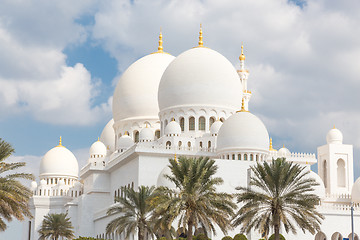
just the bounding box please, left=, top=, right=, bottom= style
left=217, top=112, right=269, bottom=152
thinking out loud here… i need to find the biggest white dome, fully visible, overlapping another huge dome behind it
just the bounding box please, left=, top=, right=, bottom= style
left=159, top=47, right=242, bottom=111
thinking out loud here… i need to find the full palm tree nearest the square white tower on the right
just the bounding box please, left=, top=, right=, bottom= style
left=233, top=158, right=324, bottom=240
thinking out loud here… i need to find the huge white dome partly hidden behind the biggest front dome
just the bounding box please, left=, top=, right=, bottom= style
left=112, top=53, right=175, bottom=122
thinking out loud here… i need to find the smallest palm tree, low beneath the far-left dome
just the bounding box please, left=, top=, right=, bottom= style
left=38, top=213, right=75, bottom=240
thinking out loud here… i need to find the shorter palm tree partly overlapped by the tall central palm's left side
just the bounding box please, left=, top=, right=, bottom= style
left=106, top=186, right=155, bottom=240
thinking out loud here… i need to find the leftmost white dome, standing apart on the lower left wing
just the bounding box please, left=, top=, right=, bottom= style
left=40, top=145, right=79, bottom=177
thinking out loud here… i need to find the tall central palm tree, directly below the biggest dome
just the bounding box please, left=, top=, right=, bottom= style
left=153, top=157, right=236, bottom=240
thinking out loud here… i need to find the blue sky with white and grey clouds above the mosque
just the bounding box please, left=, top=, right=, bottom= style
left=0, top=0, right=360, bottom=240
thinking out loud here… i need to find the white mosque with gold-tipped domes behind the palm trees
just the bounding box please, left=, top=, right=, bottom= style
left=23, top=29, right=360, bottom=240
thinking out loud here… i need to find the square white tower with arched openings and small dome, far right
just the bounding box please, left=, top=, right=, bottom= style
left=318, top=127, right=354, bottom=195
